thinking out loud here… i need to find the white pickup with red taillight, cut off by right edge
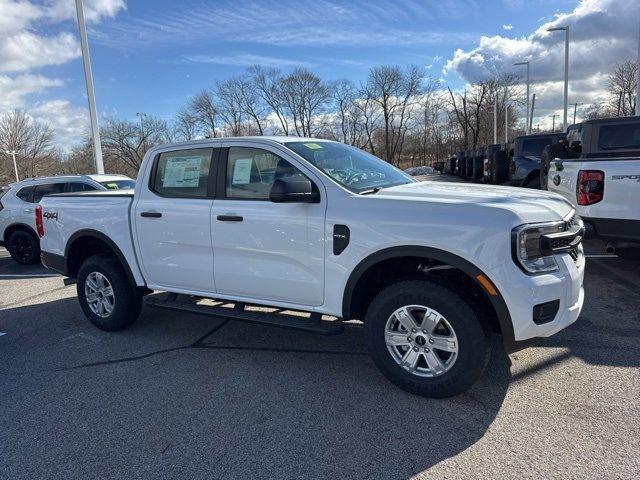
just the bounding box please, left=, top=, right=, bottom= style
left=543, top=117, right=640, bottom=260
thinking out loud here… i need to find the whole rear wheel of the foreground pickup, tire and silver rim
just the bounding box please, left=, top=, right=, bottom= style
left=77, top=255, right=142, bottom=332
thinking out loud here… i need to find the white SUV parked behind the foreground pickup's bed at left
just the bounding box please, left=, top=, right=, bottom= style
left=0, top=175, right=135, bottom=265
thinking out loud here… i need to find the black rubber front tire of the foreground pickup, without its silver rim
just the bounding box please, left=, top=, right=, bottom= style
left=365, top=280, right=491, bottom=398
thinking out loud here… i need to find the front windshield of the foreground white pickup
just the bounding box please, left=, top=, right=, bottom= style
left=285, top=142, right=415, bottom=193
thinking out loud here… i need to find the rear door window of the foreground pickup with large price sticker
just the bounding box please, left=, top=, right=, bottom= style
left=152, top=148, right=213, bottom=198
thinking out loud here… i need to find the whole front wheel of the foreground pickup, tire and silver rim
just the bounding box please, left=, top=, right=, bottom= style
left=365, top=280, right=491, bottom=398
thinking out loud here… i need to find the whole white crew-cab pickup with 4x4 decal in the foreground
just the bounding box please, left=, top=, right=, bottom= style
left=36, top=137, right=585, bottom=397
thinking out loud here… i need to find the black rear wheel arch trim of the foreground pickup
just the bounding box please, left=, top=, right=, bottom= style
left=64, top=229, right=137, bottom=288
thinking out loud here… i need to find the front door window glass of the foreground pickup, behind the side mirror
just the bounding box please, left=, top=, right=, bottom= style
left=225, top=147, right=306, bottom=200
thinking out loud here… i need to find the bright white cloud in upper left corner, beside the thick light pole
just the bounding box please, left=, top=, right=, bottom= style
left=0, top=0, right=125, bottom=150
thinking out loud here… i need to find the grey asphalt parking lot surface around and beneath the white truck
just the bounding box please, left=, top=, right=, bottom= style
left=0, top=245, right=640, bottom=479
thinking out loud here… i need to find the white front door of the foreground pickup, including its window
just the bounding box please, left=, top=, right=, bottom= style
left=211, top=142, right=326, bottom=306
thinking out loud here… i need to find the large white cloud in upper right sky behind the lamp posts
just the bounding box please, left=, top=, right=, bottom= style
left=445, top=0, right=640, bottom=122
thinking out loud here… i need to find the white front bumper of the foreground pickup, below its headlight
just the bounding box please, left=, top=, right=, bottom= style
left=491, top=246, right=585, bottom=351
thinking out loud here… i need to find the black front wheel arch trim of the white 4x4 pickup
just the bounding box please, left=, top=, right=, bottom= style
left=342, top=246, right=514, bottom=346
